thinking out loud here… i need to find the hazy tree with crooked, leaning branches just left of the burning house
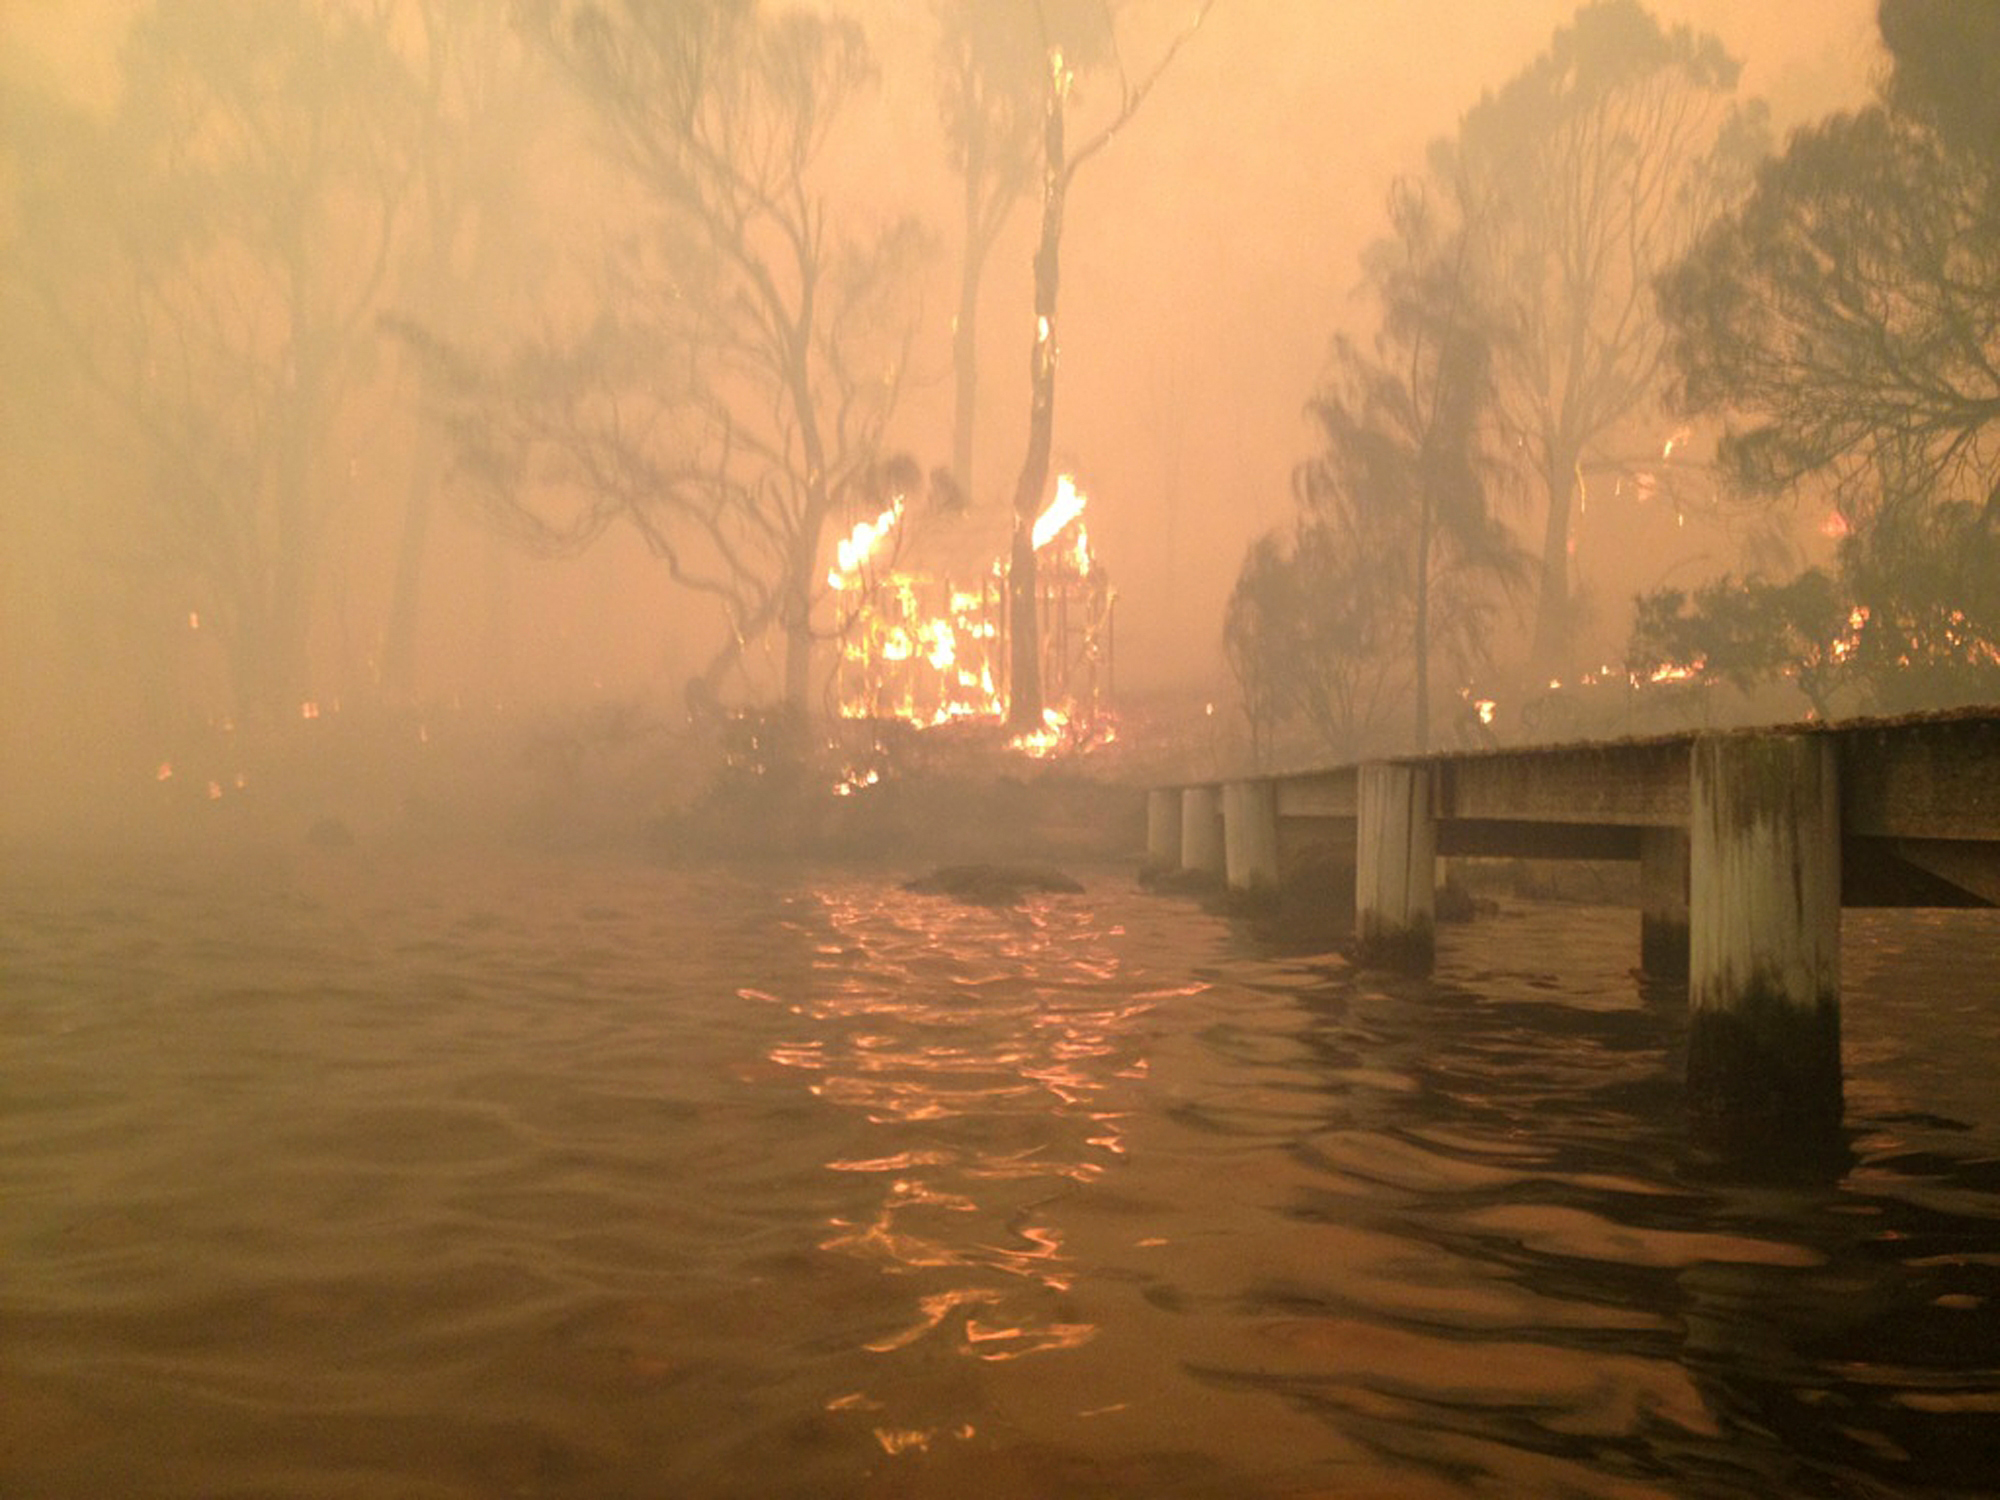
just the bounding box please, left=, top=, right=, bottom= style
left=452, top=0, right=924, bottom=714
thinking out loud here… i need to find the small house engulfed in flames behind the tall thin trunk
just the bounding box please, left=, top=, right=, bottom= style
left=826, top=474, right=1116, bottom=748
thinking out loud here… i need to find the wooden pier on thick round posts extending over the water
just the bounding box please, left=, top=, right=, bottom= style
left=1146, top=708, right=2000, bottom=1124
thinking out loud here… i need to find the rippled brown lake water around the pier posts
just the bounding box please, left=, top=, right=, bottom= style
left=0, top=850, right=2000, bottom=1500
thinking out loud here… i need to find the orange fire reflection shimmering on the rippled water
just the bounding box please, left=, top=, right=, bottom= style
left=752, top=890, right=1154, bottom=1454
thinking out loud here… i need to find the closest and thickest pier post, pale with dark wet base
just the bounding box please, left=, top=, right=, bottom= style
left=1688, top=734, right=1840, bottom=1148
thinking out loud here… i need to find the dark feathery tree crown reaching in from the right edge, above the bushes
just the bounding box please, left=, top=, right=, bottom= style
left=1662, top=6, right=2000, bottom=528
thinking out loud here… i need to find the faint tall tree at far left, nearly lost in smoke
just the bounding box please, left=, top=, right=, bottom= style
left=8, top=0, right=410, bottom=720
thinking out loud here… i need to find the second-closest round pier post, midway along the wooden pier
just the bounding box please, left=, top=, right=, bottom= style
left=1354, top=762, right=1438, bottom=974
